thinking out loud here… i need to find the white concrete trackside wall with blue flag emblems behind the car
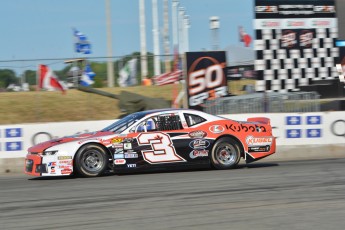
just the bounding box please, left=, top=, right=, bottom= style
left=0, top=111, right=345, bottom=158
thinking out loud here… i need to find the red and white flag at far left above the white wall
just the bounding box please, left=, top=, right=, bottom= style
left=38, top=65, right=65, bottom=92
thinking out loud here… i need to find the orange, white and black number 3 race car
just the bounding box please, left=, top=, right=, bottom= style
left=25, top=109, right=276, bottom=177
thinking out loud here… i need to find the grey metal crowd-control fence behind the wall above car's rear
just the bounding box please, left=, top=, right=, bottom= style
left=204, top=92, right=320, bottom=114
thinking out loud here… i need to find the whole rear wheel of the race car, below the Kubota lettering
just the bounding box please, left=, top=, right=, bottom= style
left=211, top=137, right=241, bottom=169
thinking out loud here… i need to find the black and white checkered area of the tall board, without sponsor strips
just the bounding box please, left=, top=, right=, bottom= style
left=254, top=27, right=339, bottom=92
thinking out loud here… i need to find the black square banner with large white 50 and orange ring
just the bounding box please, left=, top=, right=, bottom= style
left=186, top=51, right=228, bottom=110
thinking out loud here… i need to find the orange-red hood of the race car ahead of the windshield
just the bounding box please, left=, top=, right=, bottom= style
left=28, top=131, right=114, bottom=153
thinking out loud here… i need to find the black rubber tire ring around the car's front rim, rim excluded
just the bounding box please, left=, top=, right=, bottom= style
left=74, top=144, right=107, bottom=177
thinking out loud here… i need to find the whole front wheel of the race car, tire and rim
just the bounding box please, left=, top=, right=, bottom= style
left=74, top=144, right=108, bottom=177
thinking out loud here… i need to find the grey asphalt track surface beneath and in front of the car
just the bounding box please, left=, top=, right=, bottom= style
left=0, top=158, right=345, bottom=230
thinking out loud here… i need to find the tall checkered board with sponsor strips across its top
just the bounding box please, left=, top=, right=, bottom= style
left=254, top=0, right=339, bottom=93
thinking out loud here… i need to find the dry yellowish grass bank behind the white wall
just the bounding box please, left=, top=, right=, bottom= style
left=0, top=81, right=250, bottom=125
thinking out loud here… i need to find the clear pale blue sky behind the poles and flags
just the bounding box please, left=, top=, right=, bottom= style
left=0, top=0, right=254, bottom=69
